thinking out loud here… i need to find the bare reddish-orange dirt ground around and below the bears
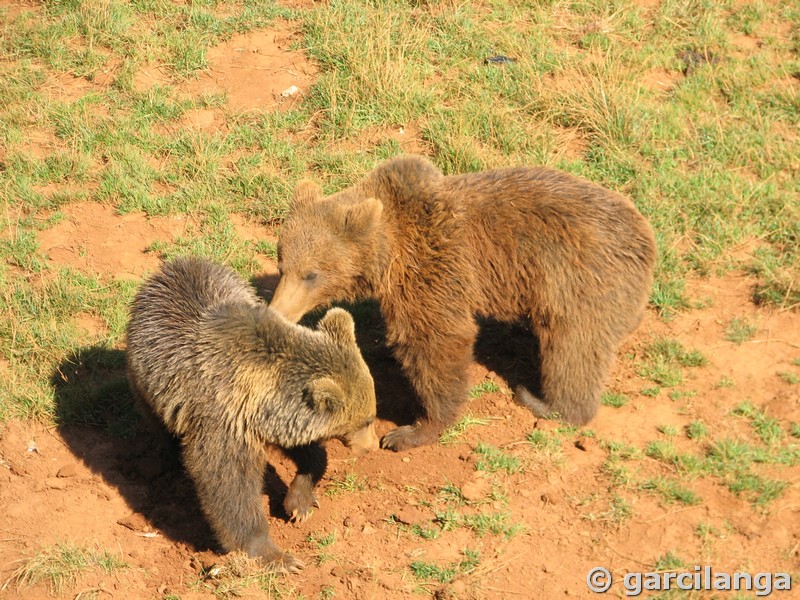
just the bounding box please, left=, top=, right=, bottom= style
left=0, top=203, right=800, bottom=598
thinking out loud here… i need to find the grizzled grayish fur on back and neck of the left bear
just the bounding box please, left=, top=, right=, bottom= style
left=127, top=258, right=365, bottom=447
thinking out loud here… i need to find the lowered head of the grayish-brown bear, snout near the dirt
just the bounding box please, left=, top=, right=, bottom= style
left=305, top=308, right=378, bottom=454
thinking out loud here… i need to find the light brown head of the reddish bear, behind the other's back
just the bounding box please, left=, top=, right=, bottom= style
left=270, top=182, right=383, bottom=323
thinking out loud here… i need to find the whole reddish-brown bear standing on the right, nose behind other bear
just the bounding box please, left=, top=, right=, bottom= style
left=270, top=156, right=656, bottom=450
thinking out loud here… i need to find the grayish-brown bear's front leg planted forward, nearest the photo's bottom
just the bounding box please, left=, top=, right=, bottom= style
left=183, top=423, right=304, bottom=573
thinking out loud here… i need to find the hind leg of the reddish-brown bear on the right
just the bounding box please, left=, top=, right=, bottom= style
left=515, top=325, right=614, bottom=425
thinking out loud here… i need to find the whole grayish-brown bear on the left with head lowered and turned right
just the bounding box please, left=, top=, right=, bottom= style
left=126, top=258, right=378, bottom=572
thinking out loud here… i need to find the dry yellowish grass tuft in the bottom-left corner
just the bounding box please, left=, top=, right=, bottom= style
left=7, top=543, right=128, bottom=595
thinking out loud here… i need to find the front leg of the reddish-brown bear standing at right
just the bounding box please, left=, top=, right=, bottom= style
left=381, top=319, right=478, bottom=452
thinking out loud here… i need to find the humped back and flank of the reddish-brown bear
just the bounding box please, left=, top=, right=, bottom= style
left=366, top=156, right=656, bottom=319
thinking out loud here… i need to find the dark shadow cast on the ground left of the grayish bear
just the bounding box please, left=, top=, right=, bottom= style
left=51, top=346, right=288, bottom=552
